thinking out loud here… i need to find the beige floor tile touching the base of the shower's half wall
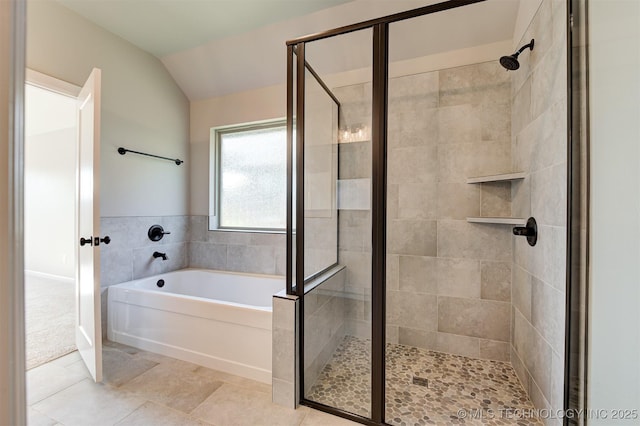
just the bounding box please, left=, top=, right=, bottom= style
left=191, top=383, right=309, bottom=426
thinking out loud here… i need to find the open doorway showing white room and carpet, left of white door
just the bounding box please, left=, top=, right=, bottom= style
left=24, top=79, right=77, bottom=370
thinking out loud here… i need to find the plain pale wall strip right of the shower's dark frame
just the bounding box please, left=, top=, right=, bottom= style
left=587, top=0, right=640, bottom=425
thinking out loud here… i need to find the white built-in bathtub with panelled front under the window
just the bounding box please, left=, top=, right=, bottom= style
left=107, top=269, right=285, bottom=383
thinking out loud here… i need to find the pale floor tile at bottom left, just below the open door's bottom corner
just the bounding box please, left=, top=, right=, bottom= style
left=33, top=379, right=144, bottom=426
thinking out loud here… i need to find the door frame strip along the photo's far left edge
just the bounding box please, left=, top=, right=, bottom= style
left=0, top=0, right=27, bottom=424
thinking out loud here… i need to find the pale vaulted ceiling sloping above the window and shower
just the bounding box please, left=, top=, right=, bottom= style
left=58, top=0, right=532, bottom=100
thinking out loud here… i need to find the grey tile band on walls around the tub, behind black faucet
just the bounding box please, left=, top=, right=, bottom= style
left=100, top=216, right=286, bottom=287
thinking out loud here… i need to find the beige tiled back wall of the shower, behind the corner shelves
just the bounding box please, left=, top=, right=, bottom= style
left=334, top=62, right=512, bottom=360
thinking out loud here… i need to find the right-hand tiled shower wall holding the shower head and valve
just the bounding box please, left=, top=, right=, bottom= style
left=511, top=0, right=567, bottom=424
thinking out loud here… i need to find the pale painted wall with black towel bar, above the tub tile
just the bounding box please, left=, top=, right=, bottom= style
left=27, top=0, right=190, bottom=216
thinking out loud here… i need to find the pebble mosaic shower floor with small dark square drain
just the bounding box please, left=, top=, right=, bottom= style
left=307, top=336, right=542, bottom=426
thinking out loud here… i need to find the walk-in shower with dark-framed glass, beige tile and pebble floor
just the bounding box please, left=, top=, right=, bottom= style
left=287, top=0, right=566, bottom=425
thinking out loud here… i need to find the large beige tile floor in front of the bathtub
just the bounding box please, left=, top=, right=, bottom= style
left=27, top=342, right=356, bottom=426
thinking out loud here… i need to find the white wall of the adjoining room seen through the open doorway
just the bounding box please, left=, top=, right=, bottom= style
left=24, top=85, right=77, bottom=279
